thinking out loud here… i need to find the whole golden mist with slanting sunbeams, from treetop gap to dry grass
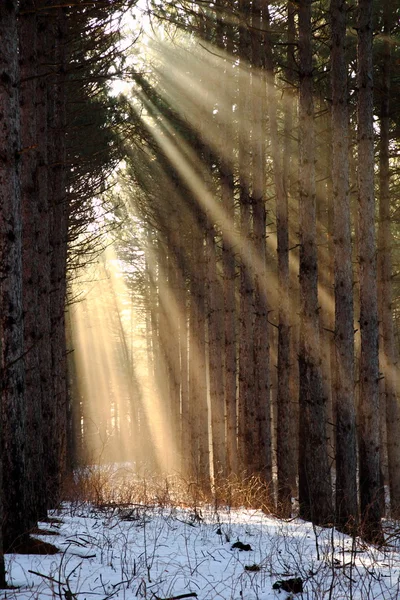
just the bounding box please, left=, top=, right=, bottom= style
left=71, top=17, right=344, bottom=488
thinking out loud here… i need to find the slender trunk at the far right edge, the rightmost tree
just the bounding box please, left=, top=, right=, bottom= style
left=378, top=2, right=400, bottom=518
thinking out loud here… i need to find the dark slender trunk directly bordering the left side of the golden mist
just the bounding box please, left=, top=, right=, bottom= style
left=44, top=3, right=68, bottom=505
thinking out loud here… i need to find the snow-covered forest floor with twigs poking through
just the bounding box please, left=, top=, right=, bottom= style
left=0, top=504, right=400, bottom=600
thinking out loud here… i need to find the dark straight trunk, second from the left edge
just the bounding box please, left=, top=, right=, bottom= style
left=19, top=0, right=45, bottom=527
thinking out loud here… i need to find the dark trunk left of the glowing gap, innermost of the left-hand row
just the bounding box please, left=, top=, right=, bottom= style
left=39, top=1, right=68, bottom=506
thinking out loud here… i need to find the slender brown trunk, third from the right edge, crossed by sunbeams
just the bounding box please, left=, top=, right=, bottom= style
left=331, top=0, right=358, bottom=527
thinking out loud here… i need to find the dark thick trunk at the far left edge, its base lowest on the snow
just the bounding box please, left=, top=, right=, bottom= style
left=0, top=1, right=29, bottom=552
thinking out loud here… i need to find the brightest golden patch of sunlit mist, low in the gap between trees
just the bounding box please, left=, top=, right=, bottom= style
left=71, top=246, right=178, bottom=472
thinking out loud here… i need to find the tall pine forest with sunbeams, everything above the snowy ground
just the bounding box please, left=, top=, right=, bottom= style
left=0, top=0, right=400, bottom=585
